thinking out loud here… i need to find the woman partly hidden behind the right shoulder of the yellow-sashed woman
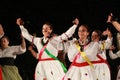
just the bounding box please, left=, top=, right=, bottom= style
left=91, top=28, right=112, bottom=80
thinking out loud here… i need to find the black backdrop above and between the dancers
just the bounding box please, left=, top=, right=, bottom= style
left=0, top=0, right=120, bottom=80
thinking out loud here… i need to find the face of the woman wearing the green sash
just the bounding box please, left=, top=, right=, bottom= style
left=42, top=24, right=53, bottom=38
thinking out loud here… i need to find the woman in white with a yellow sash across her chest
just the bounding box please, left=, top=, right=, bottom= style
left=64, top=25, right=110, bottom=80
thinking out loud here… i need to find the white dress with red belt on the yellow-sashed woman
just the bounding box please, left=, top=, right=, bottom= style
left=64, top=41, right=110, bottom=80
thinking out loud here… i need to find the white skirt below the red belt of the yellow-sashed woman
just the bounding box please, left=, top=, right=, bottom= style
left=64, top=63, right=110, bottom=80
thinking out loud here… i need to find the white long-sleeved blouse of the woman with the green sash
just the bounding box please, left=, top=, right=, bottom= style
left=20, top=25, right=77, bottom=59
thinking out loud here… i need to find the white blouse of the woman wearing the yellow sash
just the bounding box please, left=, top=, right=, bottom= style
left=63, top=40, right=99, bottom=62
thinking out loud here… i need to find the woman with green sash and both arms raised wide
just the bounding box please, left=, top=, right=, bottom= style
left=17, top=18, right=79, bottom=80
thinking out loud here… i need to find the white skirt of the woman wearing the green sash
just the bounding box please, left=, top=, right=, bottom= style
left=35, top=60, right=65, bottom=80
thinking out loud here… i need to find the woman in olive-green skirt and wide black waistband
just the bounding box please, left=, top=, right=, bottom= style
left=0, top=36, right=26, bottom=80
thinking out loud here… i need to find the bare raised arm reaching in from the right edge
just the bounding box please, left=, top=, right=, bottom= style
left=107, top=13, right=120, bottom=32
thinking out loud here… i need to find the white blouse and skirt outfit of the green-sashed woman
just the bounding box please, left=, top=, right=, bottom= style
left=20, top=25, right=77, bottom=80
